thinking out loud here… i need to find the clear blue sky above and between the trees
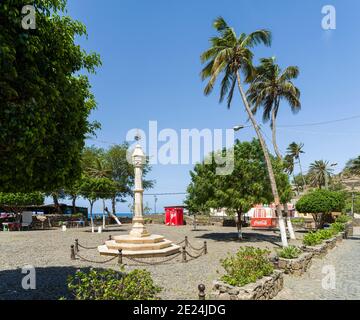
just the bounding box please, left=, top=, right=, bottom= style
left=52, top=0, right=360, bottom=212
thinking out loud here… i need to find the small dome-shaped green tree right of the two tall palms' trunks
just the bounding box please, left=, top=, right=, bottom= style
left=296, top=189, right=345, bottom=228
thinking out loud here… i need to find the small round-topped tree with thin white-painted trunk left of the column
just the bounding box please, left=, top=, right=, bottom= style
left=80, top=176, right=117, bottom=232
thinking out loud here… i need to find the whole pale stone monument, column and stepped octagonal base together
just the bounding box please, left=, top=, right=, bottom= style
left=98, top=139, right=180, bottom=258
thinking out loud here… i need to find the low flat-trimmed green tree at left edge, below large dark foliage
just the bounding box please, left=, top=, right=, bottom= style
left=0, top=192, right=45, bottom=214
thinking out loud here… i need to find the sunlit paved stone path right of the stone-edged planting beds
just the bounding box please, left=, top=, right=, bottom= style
left=275, top=227, right=360, bottom=300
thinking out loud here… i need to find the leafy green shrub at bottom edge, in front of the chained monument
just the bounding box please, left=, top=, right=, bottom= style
left=68, top=269, right=161, bottom=300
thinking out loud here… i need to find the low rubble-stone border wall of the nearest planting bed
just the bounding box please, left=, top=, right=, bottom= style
left=209, top=270, right=284, bottom=300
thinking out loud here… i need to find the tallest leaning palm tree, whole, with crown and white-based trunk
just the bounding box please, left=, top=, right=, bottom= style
left=201, top=17, right=287, bottom=246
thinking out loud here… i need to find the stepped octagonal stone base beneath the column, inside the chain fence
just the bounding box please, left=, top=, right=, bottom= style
left=98, top=234, right=180, bottom=258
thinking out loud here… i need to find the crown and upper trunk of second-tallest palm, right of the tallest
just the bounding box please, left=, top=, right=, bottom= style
left=247, top=57, right=301, bottom=159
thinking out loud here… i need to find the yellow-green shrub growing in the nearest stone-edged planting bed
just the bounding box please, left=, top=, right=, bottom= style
left=220, top=247, right=274, bottom=286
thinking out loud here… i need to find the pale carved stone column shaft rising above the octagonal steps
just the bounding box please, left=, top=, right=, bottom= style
left=130, top=144, right=150, bottom=237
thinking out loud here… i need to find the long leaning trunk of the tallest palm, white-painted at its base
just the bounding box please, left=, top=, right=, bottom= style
left=236, top=72, right=288, bottom=247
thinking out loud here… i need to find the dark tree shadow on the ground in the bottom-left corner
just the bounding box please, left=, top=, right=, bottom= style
left=0, top=267, right=98, bottom=300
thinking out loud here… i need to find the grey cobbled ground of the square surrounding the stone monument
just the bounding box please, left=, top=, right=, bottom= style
left=0, top=224, right=302, bottom=300
